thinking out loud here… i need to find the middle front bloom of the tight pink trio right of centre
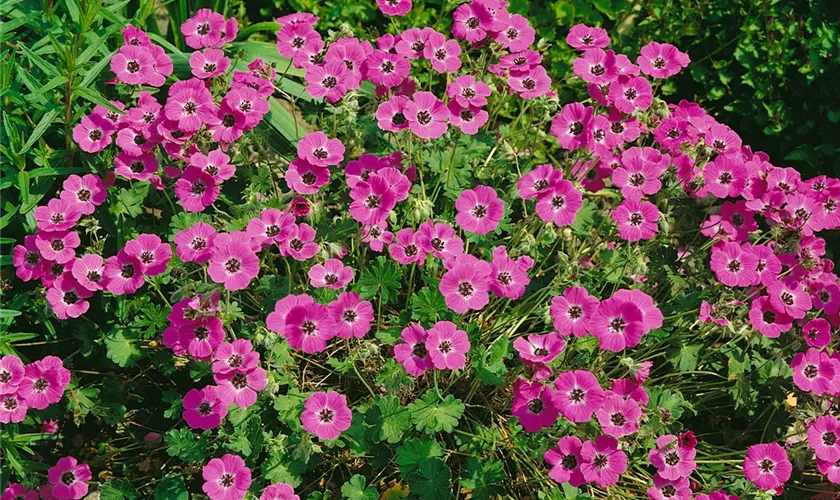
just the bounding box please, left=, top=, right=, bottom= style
left=589, top=297, right=644, bottom=352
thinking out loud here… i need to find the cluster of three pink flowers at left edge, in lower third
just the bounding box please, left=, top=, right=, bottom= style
left=0, top=354, right=70, bottom=424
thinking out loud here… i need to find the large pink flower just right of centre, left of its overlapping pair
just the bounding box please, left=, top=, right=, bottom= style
left=439, top=254, right=492, bottom=314
